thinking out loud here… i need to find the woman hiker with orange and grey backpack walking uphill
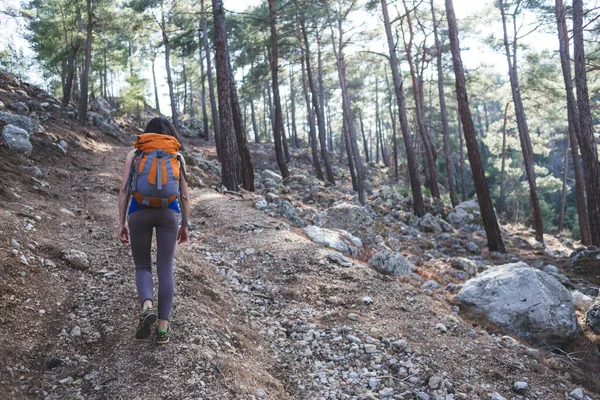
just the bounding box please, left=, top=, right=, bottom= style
left=118, top=117, right=190, bottom=344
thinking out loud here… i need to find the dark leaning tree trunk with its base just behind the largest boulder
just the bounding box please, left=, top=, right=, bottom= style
left=446, top=0, right=506, bottom=253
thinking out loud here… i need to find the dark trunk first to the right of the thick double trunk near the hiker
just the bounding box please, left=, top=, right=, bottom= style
left=269, top=0, right=290, bottom=178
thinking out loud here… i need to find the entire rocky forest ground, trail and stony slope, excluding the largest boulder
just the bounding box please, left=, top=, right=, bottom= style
left=0, top=72, right=600, bottom=400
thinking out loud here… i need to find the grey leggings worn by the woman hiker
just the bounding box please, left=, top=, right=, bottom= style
left=129, top=208, right=179, bottom=319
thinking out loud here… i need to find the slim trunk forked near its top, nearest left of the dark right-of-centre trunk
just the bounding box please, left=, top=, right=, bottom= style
left=321, top=0, right=365, bottom=204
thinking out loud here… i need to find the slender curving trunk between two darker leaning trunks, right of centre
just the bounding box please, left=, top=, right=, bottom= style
left=403, top=0, right=440, bottom=199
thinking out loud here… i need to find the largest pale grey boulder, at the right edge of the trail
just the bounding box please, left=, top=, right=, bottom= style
left=456, top=262, right=579, bottom=347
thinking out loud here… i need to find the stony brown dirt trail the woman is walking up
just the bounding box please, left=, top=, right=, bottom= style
left=0, top=138, right=600, bottom=399
